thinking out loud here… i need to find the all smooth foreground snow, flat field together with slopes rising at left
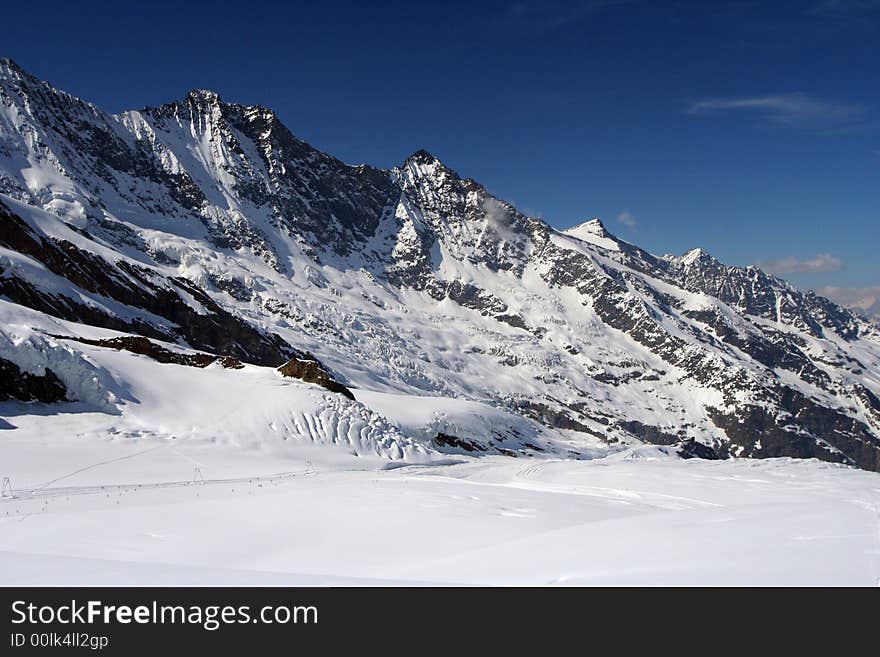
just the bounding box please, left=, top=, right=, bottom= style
left=0, top=301, right=880, bottom=585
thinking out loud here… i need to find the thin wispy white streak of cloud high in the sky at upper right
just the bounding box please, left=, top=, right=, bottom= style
left=687, top=92, right=864, bottom=125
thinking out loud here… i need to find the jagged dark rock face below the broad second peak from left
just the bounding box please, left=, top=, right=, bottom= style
left=119, top=91, right=397, bottom=265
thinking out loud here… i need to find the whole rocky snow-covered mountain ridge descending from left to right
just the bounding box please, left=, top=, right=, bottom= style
left=0, top=60, right=880, bottom=470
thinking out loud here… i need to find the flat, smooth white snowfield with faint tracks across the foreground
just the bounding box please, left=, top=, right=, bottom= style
left=0, top=432, right=880, bottom=586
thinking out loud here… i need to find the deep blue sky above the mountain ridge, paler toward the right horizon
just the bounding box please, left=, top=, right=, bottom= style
left=0, top=0, right=880, bottom=288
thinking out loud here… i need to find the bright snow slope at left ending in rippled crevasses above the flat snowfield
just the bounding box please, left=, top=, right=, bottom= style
left=0, top=301, right=430, bottom=461
